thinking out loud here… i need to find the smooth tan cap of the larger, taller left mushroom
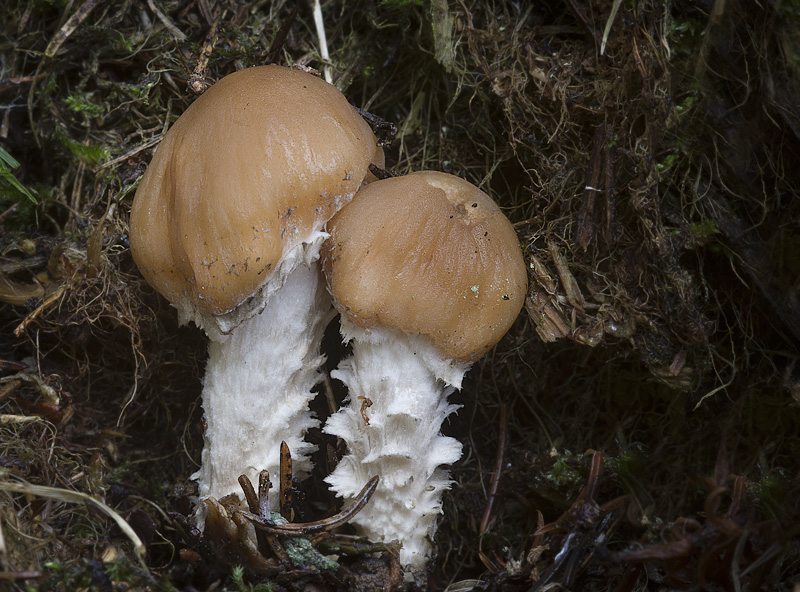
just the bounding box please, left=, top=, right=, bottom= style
left=130, top=66, right=383, bottom=315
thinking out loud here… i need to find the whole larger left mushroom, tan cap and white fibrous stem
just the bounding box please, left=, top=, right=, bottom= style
left=130, top=66, right=383, bottom=522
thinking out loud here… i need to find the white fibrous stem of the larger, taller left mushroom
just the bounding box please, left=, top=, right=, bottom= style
left=192, top=262, right=332, bottom=512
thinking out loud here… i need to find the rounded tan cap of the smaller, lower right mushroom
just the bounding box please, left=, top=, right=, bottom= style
left=322, top=172, right=528, bottom=361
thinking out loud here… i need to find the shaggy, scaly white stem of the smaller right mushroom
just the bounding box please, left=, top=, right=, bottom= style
left=324, top=318, right=469, bottom=574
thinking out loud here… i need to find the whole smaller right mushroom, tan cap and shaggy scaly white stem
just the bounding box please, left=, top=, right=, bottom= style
left=322, top=172, right=527, bottom=577
